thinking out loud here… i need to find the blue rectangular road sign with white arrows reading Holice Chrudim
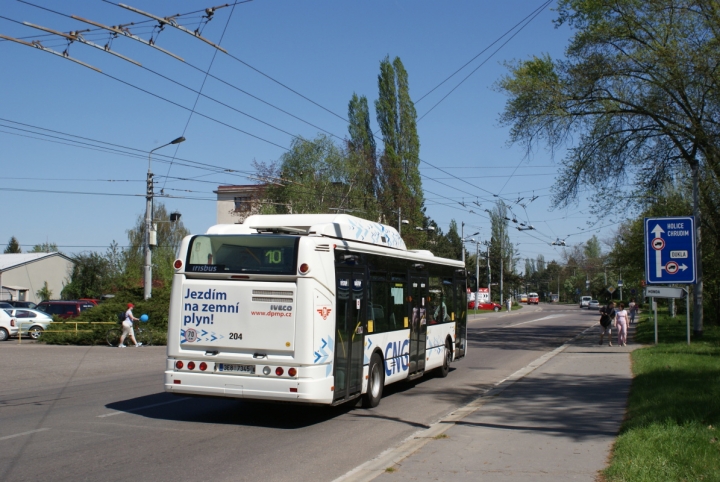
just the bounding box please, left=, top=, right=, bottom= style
left=645, top=216, right=695, bottom=284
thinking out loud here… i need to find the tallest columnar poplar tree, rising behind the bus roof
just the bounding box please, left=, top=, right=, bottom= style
left=375, top=56, right=424, bottom=245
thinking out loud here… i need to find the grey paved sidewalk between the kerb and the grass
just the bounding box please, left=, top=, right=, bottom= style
left=358, top=326, right=638, bottom=482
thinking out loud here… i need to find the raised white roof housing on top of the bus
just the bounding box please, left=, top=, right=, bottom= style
left=207, top=214, right=407, bottom=251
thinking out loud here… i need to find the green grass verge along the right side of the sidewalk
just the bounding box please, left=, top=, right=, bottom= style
left=603, top=315, right=720, bottom=481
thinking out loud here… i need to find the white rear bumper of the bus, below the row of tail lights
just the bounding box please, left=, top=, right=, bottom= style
left=165, top=370, right=334, bottom=404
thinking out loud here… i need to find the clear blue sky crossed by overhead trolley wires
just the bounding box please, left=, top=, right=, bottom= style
left=0, top=0, right=597, bottom=268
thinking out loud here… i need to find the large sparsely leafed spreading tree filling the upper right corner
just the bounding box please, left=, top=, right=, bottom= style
left=499, top=0, right=720, bottom=334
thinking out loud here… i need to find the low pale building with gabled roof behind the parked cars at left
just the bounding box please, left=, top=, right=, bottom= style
left=0, top=253, right=74, bottom=303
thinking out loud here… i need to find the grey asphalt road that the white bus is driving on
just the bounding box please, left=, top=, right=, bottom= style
left=0, top=304, right=597, bottom=482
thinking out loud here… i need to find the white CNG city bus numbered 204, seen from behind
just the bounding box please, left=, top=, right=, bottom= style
left=165, top=214, right=467, bottom=407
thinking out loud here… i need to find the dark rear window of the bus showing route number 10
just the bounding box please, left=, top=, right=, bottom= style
left=185, top=234, right=299, bottom=274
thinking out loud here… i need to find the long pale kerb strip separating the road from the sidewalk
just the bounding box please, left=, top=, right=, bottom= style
left=333, top=320, right=597, bottom=482
